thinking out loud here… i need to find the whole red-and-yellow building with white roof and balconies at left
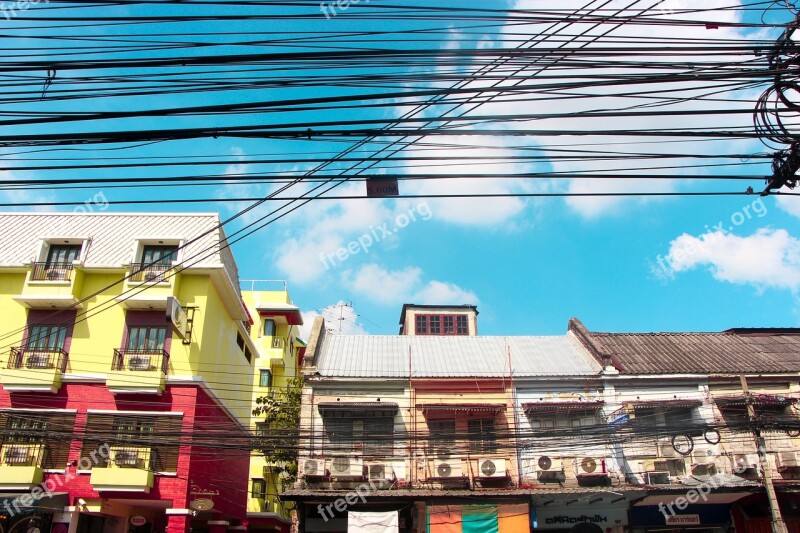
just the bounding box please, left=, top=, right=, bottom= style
left=0, top=213, right=258, bottom=533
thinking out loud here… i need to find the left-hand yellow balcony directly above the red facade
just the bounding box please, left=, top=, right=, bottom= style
left=0, top=347, right=68, bottom=393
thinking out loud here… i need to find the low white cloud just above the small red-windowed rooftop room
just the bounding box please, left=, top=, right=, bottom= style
left=342, top=263, right=478, bottom=304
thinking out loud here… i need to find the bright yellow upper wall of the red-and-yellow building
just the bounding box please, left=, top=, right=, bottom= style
left=0, top=269, right=255, bottom=427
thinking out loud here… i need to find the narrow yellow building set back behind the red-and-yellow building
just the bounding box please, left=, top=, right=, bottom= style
left=242, top=281, right=305, bottom=531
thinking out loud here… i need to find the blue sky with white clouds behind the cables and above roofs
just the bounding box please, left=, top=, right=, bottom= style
left=0, top=0, right=800, bottom=335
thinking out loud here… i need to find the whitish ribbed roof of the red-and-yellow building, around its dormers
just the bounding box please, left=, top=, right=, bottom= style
left=0, top=213, right=239, bottom=288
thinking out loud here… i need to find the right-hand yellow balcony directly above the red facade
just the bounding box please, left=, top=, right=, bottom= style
left=106, top=350, right=169, bottom=394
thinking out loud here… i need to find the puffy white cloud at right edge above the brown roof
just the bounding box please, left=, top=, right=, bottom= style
left=667, top=225, right=800, bottom=292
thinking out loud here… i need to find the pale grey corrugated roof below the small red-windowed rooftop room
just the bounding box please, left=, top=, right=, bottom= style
left=316, top=334, right=601, bottom=379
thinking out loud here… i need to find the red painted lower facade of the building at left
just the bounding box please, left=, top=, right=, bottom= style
left=0, top=383, right=249, bottom=533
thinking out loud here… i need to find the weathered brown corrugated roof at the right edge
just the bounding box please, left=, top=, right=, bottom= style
left=587, top=332, right=800, bottom=374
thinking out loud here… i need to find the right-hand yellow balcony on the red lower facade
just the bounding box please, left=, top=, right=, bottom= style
left=89, top=446, right=156, bottom=492
